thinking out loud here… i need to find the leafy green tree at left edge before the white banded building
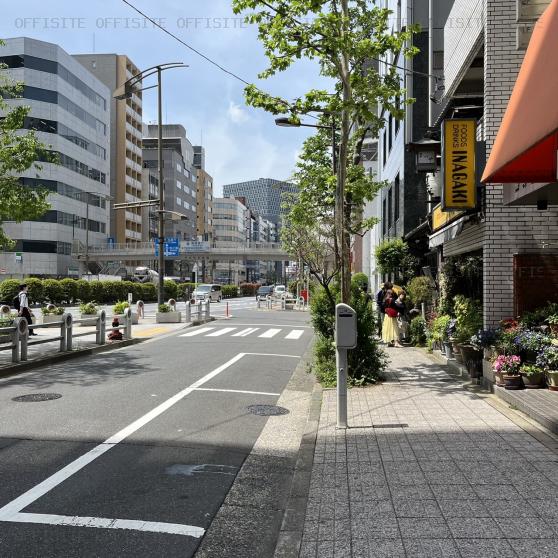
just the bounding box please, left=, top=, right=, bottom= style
left=0, top=41, right=55, bottom=250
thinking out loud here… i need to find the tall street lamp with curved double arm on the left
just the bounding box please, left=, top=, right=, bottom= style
left=114, top=62, right=188, bottom=304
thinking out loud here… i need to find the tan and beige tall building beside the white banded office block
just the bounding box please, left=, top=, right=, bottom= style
left=74, top=54, right=143, bottom=244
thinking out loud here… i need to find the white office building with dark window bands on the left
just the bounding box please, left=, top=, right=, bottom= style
left=0, top=37, right=111, bottom=277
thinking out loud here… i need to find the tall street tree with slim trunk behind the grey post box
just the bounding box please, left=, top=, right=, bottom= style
left=232, top=0, right=417, bottom=302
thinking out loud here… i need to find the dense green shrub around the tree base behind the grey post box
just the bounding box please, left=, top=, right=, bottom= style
left=310, top=283, right=388, bottom=386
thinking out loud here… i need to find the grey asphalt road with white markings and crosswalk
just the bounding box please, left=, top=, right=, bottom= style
left=0, top=308, right=312, bottom=558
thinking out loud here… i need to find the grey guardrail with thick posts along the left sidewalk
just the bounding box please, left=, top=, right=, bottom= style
left=0, top=308, right=132, bottom=363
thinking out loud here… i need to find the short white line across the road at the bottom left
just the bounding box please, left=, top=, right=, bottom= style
left=10, top=513, right=205, bottom=539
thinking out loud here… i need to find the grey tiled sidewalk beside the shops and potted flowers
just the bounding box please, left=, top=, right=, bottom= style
left=300, top=348, right=558, bottom=558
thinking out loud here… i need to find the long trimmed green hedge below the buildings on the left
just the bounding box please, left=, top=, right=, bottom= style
left=0, top=277, right=238, bottom=306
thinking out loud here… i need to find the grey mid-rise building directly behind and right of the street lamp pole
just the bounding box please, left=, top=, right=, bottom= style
left=143, top=124, right=197, bottom=240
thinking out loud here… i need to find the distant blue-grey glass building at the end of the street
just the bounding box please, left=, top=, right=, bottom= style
left=223, top=178, right=297, bottom=231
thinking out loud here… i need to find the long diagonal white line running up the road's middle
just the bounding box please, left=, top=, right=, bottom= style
left=0, top=353, right=246, bottom=540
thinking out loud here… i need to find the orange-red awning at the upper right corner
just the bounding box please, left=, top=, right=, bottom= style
left=482, top=0, right=558, bottom=183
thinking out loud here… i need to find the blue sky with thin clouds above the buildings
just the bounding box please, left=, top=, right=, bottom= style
left=0, top=0, right=327, bottom=195
